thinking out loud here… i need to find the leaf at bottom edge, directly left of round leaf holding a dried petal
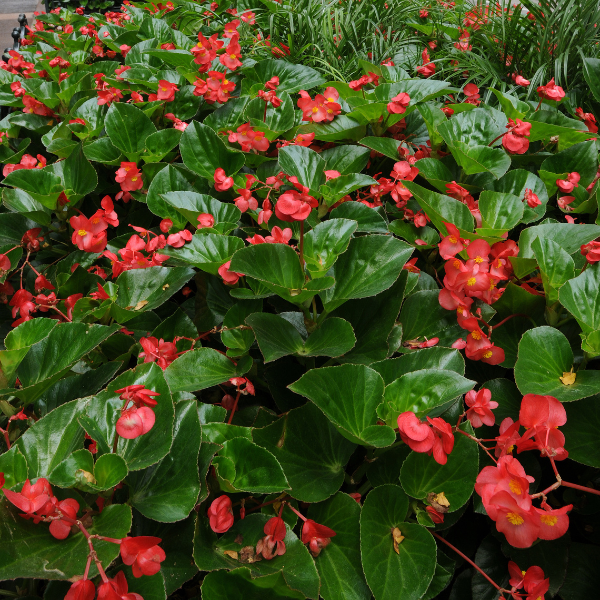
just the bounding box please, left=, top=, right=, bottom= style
left=308, top=492, right=371, bottom=600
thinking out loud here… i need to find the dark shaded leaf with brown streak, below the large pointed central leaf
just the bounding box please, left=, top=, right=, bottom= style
left=252, top=402, right=356, bottom=502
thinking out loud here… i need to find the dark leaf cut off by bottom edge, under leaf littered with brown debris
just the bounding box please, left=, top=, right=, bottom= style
left=202, top=568, right=304, bottom=600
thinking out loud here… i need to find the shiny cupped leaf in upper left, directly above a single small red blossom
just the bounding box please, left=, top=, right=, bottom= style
left=179, top=121, right=244, bottom=182
